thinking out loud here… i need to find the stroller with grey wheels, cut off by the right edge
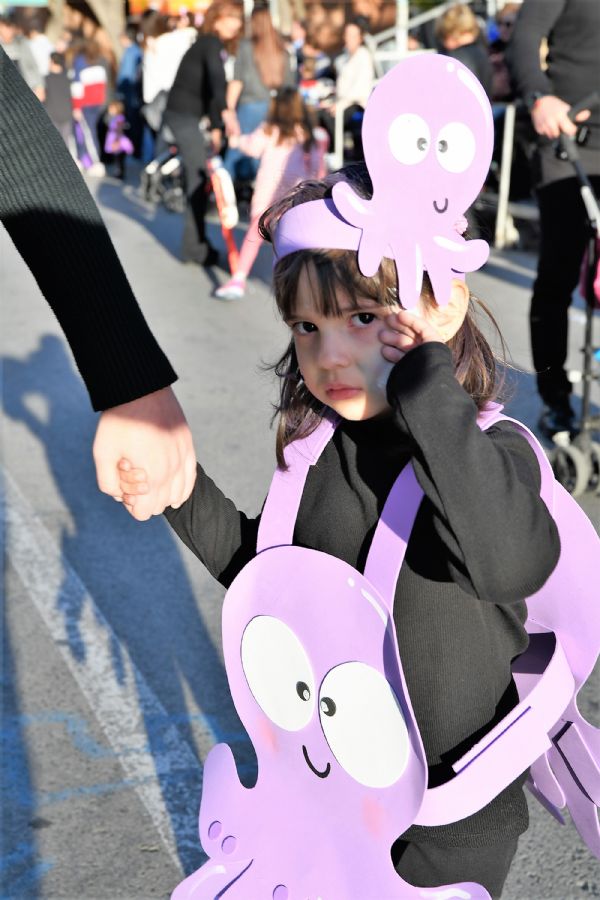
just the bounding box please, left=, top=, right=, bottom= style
left=550, top=93, right=600, bottom=497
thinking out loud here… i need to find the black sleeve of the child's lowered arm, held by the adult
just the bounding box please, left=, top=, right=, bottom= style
left=164, top=464, right=260, bottom=587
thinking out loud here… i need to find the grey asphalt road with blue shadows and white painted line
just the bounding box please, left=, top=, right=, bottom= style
left=0, top=171, right=600, bottom=900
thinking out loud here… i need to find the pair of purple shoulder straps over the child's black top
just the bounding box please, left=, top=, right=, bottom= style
left=257, top=417, right=423, bottom=615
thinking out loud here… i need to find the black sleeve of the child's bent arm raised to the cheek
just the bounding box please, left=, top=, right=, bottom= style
left=388, top=342, right=560, bottom=603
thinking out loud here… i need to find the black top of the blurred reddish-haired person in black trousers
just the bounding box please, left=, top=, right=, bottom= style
left=167, top=34, right=227, bottom=128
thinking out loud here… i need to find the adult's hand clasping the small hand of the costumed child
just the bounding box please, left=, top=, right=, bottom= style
left=93, top=387, right=196, bottom=522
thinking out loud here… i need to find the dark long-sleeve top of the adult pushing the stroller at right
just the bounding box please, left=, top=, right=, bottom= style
left=505, top=0, right=600, bottom=148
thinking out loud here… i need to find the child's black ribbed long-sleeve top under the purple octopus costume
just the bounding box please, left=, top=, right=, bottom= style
left=166, top=343, right=560, bottom=846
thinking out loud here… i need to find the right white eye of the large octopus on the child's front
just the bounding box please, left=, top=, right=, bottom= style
left=319, top=662, right=409, bottom=788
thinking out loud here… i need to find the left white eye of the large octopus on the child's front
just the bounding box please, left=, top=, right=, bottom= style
left=242, top=616, right=315, bottom=731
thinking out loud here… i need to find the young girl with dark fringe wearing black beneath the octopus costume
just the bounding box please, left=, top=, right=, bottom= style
left=121, top=164, right=560, bottom=900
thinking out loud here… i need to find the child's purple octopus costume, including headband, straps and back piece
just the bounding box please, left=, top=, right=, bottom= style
left=173, top=56, right=600, bottom=900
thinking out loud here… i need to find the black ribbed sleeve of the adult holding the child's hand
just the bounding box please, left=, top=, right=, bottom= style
left=0, top=47, right=177, bottom=410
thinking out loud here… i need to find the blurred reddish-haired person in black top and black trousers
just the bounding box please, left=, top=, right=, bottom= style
left=164, top=0, right=242, bottom=266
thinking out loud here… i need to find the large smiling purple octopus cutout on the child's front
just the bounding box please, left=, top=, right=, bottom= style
left=172, top=546, right=489, bottom=900
